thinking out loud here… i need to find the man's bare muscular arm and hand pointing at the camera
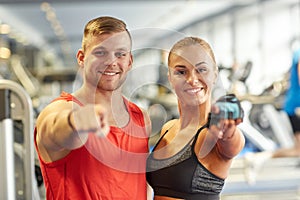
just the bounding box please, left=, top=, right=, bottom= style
left=36, top=101, right=109, bottom=161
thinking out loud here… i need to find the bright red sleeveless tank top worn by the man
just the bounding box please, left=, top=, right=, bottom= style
left=34, top=92, right=148, bottom=200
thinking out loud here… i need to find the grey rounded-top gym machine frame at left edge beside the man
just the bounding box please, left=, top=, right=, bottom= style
left=0, top=80, right=40, bottom=200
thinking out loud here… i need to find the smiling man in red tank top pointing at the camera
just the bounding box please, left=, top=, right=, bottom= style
left=35, top=16, right=151, bottom=200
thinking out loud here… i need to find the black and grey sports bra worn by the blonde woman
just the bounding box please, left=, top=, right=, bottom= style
left=146, top=125, right=224, bottom=200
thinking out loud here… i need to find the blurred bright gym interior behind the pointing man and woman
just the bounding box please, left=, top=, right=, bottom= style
left=0, top=0, right=300, bottom=200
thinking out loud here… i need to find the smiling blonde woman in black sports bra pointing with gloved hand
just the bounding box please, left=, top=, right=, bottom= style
left=147, top=37, right=245, bottom=200
